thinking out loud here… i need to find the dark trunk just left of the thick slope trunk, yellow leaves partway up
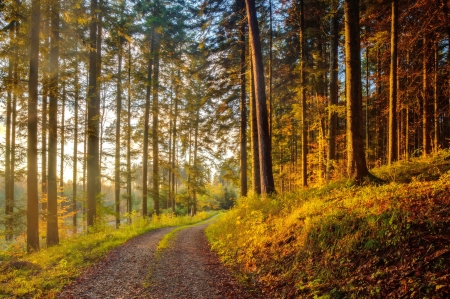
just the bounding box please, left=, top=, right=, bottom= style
left=326, top=0, right=340, bottom=181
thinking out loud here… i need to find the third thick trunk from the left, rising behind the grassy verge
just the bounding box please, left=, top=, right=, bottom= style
left=86, top=0, right=100, bottom=226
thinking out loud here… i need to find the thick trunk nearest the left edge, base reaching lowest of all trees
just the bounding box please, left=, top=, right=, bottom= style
left=27, top=0, right=41, bottom=252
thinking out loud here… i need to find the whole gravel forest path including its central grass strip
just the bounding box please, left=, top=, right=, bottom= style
left=58, top=221, right=255, bottom=299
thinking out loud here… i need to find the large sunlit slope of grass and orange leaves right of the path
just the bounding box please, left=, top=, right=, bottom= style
left=207, top=151, right=450, bottom=298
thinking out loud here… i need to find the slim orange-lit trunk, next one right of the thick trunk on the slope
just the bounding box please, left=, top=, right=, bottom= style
left=388, top=0, right=398, bottom=165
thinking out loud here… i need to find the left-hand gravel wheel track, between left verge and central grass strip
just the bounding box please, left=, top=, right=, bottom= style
left=59, top=227, right=173, bottom=299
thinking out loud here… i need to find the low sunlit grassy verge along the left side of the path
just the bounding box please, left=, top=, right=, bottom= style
left=0, top=212, right=213, bottom=298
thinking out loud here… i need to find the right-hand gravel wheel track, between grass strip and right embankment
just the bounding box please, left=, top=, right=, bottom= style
left=143, top=223, right=256, bottom=299
